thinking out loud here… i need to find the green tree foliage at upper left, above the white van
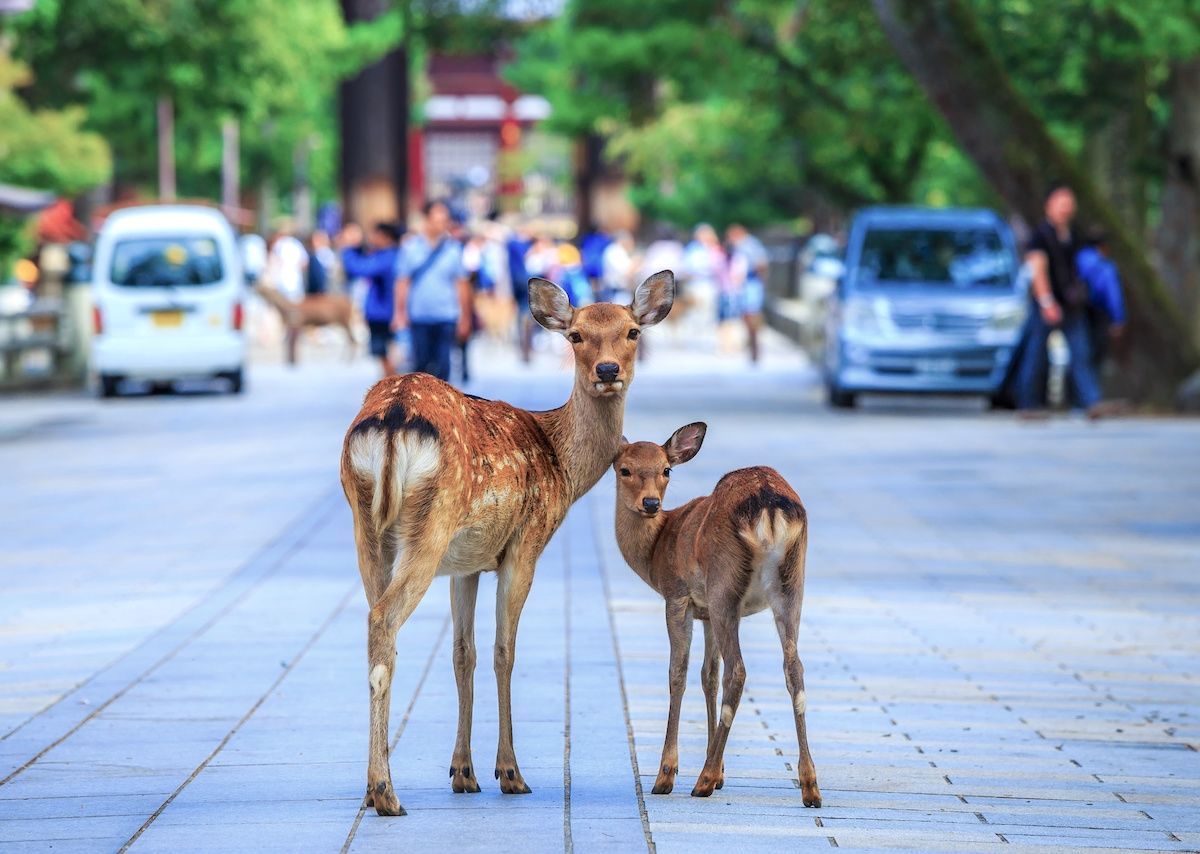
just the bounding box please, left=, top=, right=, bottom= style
left=3, top=0, right=401, bottom=206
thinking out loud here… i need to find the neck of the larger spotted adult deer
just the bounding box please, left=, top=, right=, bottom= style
left=535, top=386, right=625, bottom=503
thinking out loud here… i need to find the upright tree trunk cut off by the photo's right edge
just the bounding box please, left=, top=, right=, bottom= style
left=1158, top=59, right=1200, bottom=341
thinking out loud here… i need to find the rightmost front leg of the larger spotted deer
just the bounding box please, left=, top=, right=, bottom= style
left=494, top=554, right=535, bottom=795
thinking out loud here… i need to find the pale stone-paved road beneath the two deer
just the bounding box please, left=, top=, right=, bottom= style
left=0, top=331, right=1200, bottom=853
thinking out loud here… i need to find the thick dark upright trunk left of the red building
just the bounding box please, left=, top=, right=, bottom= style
left=338, top=0, right=409, bottom=225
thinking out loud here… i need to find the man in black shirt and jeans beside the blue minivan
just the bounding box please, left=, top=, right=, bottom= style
left=1016, top=185, right=1100, bottom=414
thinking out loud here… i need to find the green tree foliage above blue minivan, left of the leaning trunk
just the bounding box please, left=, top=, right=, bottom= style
left=509, top=0, right=988, bottom=224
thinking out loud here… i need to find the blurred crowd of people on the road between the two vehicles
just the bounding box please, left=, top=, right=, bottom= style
left=264, top=200, right=767, bottom=381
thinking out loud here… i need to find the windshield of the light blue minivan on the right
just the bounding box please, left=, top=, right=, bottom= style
left=857, top=227, right=1016, bottom=288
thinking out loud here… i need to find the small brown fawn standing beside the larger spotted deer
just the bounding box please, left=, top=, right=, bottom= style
left=613, top=422, right=821, bottom=807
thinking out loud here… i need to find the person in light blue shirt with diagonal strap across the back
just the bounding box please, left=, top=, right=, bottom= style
left=391, top=200, right=472, bottom=381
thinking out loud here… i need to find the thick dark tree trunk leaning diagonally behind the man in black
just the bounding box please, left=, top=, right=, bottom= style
left=872, top=0, right=1200, bottom=401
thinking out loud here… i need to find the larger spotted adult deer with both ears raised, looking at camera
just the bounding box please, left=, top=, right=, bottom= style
left=342, top=271, right=674, bottom=816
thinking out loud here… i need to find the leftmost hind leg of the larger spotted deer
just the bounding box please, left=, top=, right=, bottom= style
left=367, top=524, right=449, bottom=816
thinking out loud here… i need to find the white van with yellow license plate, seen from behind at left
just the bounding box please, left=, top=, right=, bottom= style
left=91, top=205, right=246, bottom=397
